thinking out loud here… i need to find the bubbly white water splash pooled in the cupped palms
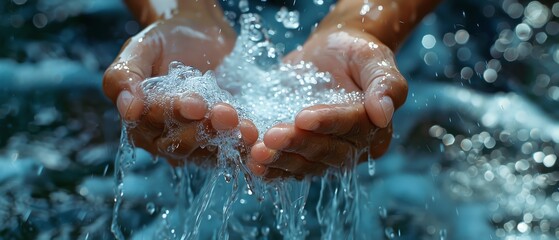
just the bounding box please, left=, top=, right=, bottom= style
left=142, top=15, right=363, bottom=138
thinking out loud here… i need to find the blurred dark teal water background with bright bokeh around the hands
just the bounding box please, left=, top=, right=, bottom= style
left=0, top=0, right=559, bottom=239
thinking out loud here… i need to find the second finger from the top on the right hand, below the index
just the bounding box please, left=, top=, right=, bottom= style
left=264, top=124, right=355, bottom=167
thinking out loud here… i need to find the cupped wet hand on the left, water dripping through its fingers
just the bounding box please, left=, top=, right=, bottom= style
left=103, top=7, right=258, bottom=164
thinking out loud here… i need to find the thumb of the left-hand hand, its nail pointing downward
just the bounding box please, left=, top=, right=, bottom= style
left=103, top=24, right=160, bottom=120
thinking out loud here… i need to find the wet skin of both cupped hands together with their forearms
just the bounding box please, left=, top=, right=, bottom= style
left=103, top=0, right=437, bottom=178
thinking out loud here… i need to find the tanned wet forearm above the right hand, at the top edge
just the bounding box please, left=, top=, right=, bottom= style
left=317, top=0, right=440, bottom=51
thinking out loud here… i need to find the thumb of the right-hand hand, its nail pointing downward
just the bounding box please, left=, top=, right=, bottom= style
left=350, top=39, right=408, bottom=127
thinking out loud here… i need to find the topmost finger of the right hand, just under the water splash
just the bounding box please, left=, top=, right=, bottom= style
left=295, top=104, right=373, bottom=138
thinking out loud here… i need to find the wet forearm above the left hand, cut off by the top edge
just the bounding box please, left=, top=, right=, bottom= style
left=124, top=0, right=223, bottom=26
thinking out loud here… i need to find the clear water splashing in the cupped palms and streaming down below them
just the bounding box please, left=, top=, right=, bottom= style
left=111, top=14, right=371, bottom=239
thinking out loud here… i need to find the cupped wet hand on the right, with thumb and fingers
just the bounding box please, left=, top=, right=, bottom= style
left=249, top=28, right=408, bottom=178
